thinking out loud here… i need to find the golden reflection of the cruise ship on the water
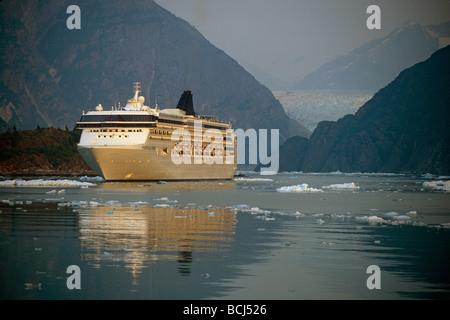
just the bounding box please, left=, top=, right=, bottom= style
left=79, top=202, right=236, bottom=278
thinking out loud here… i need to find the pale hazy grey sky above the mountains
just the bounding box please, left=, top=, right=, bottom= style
left=155, top=0, right=450, bottom=87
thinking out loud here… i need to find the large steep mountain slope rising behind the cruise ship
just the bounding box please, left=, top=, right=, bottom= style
left=0, top=0, right=310, bottom=140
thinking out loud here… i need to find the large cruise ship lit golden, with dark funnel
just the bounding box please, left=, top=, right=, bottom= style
left=75, top=83, right=237, bottom=181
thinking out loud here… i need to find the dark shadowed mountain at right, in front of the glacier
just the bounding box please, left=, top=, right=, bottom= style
left=280, top=46, right=450, bottom=174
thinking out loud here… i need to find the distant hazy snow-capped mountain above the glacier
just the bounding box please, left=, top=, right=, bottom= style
left=294, top=23, right=450, bottom=92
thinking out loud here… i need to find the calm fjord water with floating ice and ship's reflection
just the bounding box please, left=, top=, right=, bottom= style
left=0, top=173, right=450, bottom=300
